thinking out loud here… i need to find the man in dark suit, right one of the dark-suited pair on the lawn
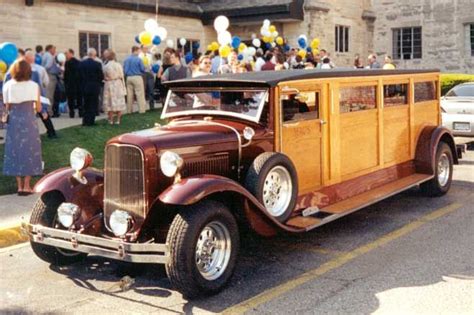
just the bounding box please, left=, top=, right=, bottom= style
left=79, top=48, right=104, bottom=126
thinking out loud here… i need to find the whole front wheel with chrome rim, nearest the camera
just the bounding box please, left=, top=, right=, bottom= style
left=166, top=200, right=239, bottom=298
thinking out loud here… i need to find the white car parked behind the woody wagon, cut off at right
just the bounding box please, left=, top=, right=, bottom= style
left=441, top=82, right=474, bottom=137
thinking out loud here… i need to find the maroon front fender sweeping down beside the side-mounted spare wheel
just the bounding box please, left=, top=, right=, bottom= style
left=158, top=175, right=305, bottom=235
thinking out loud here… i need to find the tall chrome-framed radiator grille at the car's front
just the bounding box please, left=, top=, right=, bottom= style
left=104, top=144, right=146, bottom=217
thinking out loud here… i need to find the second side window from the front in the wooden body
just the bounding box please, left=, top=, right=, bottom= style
left=339, top=85, right=377, bottom=113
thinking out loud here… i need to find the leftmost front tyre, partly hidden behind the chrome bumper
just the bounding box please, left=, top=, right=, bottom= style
left=30, top=194, right=87, bottom=266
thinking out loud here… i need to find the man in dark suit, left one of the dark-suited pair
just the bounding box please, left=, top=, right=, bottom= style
left=64, top=49, right=84, bottom=118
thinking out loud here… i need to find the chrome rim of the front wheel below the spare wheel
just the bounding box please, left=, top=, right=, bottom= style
left=195, top=221, right=232, bottom=280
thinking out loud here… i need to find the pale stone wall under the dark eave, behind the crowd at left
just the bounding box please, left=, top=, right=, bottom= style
left=0, top=0, right=208, bottom=60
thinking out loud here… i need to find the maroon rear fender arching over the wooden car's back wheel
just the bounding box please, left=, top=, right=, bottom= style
left=415, top=126, right=458, bottom=174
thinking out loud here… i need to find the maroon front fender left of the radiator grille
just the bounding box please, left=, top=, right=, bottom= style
left=34, top=167, right=104, bottom=201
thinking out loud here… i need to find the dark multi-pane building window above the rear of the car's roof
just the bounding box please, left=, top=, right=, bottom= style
left=393, top=27, right=422, bottom=60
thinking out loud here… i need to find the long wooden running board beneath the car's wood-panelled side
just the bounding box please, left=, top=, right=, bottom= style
left=286, top=173, right=433, bottom=231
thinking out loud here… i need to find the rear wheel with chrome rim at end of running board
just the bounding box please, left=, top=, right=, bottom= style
left=420, top=142, right=453, bottom=197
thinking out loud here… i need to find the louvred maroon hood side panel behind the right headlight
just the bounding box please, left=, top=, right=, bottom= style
left=182, top=154, right=230, bottom=177
